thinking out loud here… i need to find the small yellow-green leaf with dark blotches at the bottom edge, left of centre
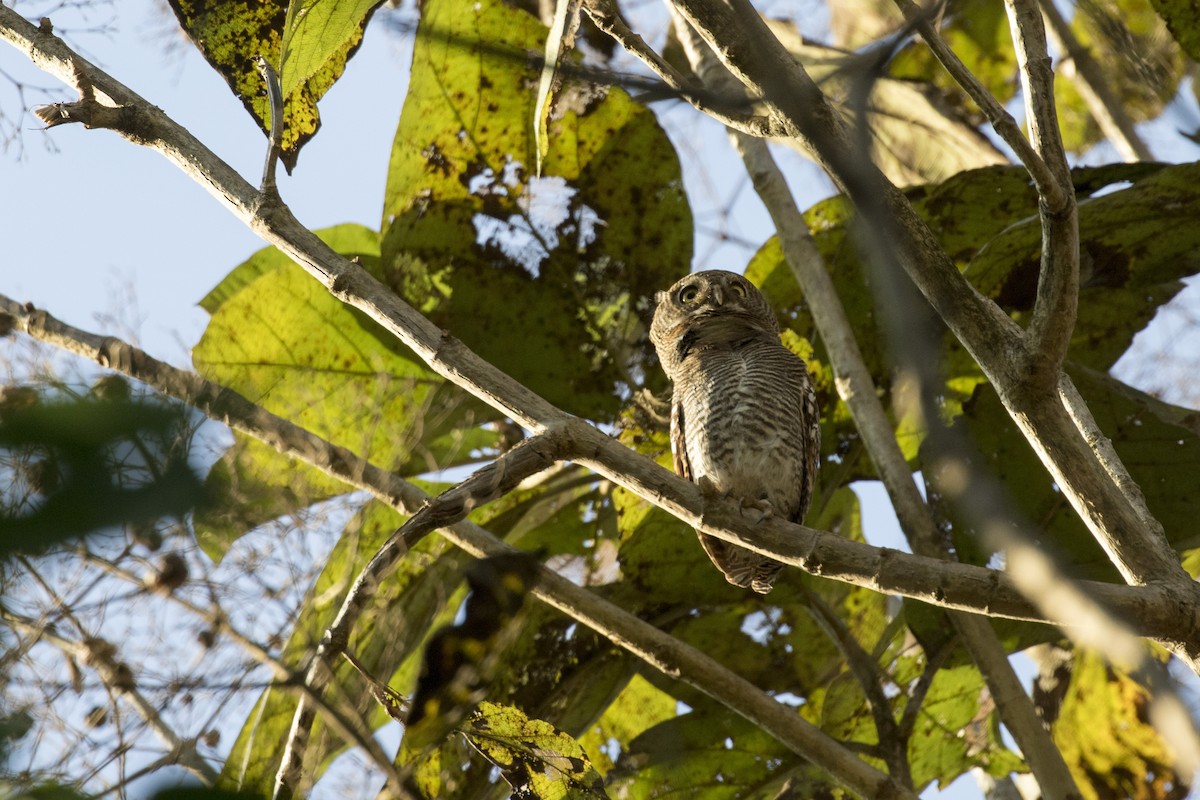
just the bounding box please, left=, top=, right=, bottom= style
left=462, top=702, right=608, bottom=800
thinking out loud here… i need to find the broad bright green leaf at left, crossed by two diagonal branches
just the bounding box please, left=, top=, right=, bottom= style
left=192, top=225, right=497, bottom=558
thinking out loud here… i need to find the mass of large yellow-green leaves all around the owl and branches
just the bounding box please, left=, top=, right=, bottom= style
left=7, top=0, right=1200, bottom=799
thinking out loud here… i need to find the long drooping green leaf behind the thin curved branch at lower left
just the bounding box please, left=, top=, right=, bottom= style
left=221, top=503, right=468, bottom=796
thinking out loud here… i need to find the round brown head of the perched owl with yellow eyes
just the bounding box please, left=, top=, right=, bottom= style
left=650, top=270, right=779, bottom=375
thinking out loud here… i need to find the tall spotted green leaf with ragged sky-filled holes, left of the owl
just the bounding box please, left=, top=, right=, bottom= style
left=383, top=0, right=691, bottom=420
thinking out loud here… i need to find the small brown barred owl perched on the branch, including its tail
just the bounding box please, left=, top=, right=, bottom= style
left=650, top=270, right=821, bottom=594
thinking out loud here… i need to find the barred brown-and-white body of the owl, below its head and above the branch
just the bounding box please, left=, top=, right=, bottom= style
left=674, top=341, right=811, bottom=518
